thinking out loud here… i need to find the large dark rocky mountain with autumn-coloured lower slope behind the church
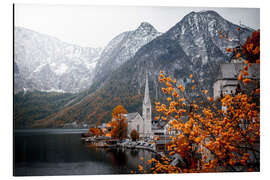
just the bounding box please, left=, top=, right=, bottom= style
left=30, top=11, right=254, bottom=127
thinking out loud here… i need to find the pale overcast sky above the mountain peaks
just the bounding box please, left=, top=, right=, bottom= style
left=14, top=4, right=260, bottom=47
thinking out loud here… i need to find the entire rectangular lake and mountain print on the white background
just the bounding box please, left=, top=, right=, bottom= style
left=12, top=3, right=265, bottom=176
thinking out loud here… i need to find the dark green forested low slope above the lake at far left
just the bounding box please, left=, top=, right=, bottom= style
left=14, top=91, right=76, bottom=129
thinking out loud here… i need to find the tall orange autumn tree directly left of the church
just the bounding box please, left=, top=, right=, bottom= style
left=111, top=105, right=127, bottom=140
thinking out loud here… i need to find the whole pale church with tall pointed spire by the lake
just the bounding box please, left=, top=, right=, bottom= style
left=126, top=75, right=153, bottom=137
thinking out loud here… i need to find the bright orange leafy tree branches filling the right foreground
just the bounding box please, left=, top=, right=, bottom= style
left=140, top=29, right=260, bottom=173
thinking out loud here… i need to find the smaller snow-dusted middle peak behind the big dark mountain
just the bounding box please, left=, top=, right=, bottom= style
left=95, top=22, right=161, bottom=87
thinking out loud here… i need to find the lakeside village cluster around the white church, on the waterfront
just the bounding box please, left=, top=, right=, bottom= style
left=81, top=76, right=172, bottom=155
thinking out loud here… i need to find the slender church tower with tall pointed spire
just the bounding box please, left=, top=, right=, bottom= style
left=142, top=73, right=152, bottom=136
